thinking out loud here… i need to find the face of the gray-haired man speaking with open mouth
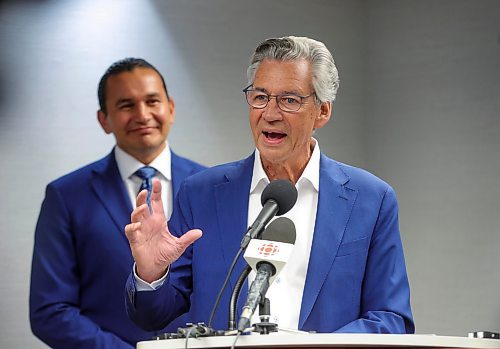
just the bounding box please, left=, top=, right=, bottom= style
left=249, top=59, right=331, bottom=178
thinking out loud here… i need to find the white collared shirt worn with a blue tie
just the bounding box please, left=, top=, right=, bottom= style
left=115, top=143, right=173, bottom=218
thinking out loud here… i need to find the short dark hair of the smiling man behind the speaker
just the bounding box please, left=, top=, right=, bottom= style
left=97, top=57, right=168, bottom=114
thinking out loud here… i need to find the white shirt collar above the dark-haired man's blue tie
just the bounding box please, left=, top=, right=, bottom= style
left=115, top=142, right=172, bottom=181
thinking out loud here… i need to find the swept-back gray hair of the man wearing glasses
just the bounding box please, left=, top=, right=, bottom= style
left=247, top=36, right=339, bottom=102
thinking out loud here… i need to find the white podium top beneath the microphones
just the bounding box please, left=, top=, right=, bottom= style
left=137, top=333, right=500, bottom=349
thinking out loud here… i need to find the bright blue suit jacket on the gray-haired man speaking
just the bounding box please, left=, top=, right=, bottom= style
left=126, top=155, right=414, bottom=333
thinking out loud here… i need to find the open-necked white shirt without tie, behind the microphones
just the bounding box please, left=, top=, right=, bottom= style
left=248, top=141, right=320, bottom=330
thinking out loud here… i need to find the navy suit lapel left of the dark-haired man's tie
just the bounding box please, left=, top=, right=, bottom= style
left=91, top=151, right=132, bottom=243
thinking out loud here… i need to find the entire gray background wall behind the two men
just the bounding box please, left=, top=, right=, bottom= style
left=0, top=0, right=500, bottom=348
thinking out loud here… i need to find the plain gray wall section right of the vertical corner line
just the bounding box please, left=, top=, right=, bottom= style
left=364, top=0, right=500, bottom=335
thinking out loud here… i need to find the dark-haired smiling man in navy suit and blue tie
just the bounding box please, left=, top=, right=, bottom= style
left=30, top=58, right=204, bottom=349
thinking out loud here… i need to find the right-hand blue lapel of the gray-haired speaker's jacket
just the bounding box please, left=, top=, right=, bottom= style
left=299, top=154, right=357, bottom=329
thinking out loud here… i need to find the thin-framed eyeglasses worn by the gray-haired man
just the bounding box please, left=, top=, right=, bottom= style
left=243, top=85, right=315, bottom=112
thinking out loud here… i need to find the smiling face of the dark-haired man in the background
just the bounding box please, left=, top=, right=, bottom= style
left=97, top=68, right=175, bottom=164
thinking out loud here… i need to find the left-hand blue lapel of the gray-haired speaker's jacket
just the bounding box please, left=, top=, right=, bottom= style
left=214, top=155, right=254, bottom=297
